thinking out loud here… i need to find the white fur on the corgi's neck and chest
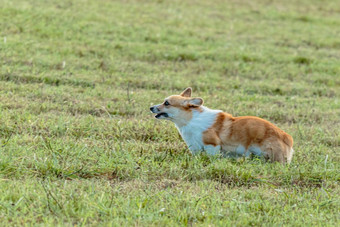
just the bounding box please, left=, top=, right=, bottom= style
left=176, top=106, right=222, bottom=154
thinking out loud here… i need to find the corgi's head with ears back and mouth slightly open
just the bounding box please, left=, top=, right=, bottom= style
left=150, top=87, right=203, bottom=123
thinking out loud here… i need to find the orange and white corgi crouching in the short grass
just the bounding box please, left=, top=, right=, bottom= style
left=150, top=87, right=294, bottom=163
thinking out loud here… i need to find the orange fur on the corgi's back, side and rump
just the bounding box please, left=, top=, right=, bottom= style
left=203, top=112, right=293, bottom=163
